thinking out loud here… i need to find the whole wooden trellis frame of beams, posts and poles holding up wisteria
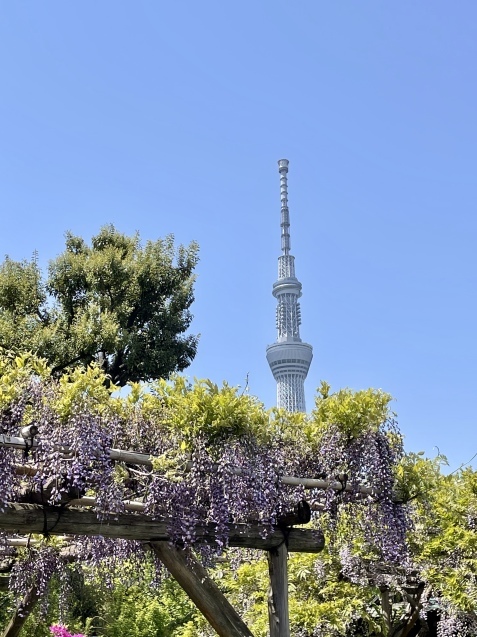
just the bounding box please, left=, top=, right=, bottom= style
left=0, top=435, right=336, bottom=637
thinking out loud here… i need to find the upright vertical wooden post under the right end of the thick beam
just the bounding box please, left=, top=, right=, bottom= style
left=267, top=543, right=290, bottom=637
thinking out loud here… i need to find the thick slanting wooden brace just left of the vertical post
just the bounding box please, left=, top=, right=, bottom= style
left=151, top=542, right=253, bottom=637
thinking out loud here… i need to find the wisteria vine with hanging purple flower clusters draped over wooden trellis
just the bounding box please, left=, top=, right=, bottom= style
left=0, top=362, right=407, bottom=632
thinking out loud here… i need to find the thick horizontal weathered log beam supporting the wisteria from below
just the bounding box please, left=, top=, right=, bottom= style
left=0, top=503, right=324, bottom=553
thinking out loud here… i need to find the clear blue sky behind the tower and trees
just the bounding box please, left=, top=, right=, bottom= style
left=0, top=0, right=477, bottom=467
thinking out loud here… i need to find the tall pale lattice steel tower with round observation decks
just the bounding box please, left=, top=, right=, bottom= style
left=267, top=159, right=313, bottom=411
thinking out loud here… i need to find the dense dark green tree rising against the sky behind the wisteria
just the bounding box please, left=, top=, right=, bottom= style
left=0, top=225, right=198, bottom=386
